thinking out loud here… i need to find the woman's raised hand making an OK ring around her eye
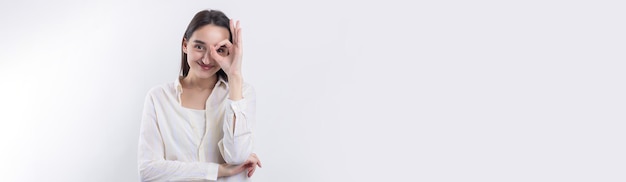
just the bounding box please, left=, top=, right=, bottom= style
left=209, top=19, right=243, bottom=77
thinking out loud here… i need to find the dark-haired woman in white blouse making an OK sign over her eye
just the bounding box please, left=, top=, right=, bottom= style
left=138, top=10, right=261, bottom=181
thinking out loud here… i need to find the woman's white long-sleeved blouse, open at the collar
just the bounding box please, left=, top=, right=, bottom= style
left=138, top=76, right=256, bottom=181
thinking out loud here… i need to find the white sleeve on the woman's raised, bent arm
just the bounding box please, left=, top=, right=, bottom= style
left=218, top=85, right=256, bottom=164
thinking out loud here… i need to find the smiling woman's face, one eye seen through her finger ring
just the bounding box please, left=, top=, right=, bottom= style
left=183, top=24, right=229, bottom=78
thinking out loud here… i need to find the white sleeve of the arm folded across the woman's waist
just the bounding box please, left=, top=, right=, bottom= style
left=138, top=92, right=219, bottom=181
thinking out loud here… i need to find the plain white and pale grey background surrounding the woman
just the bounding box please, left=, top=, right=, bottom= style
left=0, top=0, right=626, bottom=182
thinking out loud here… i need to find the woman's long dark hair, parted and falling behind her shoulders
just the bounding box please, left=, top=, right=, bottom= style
left=180, top=10, right=233, bottom=81
